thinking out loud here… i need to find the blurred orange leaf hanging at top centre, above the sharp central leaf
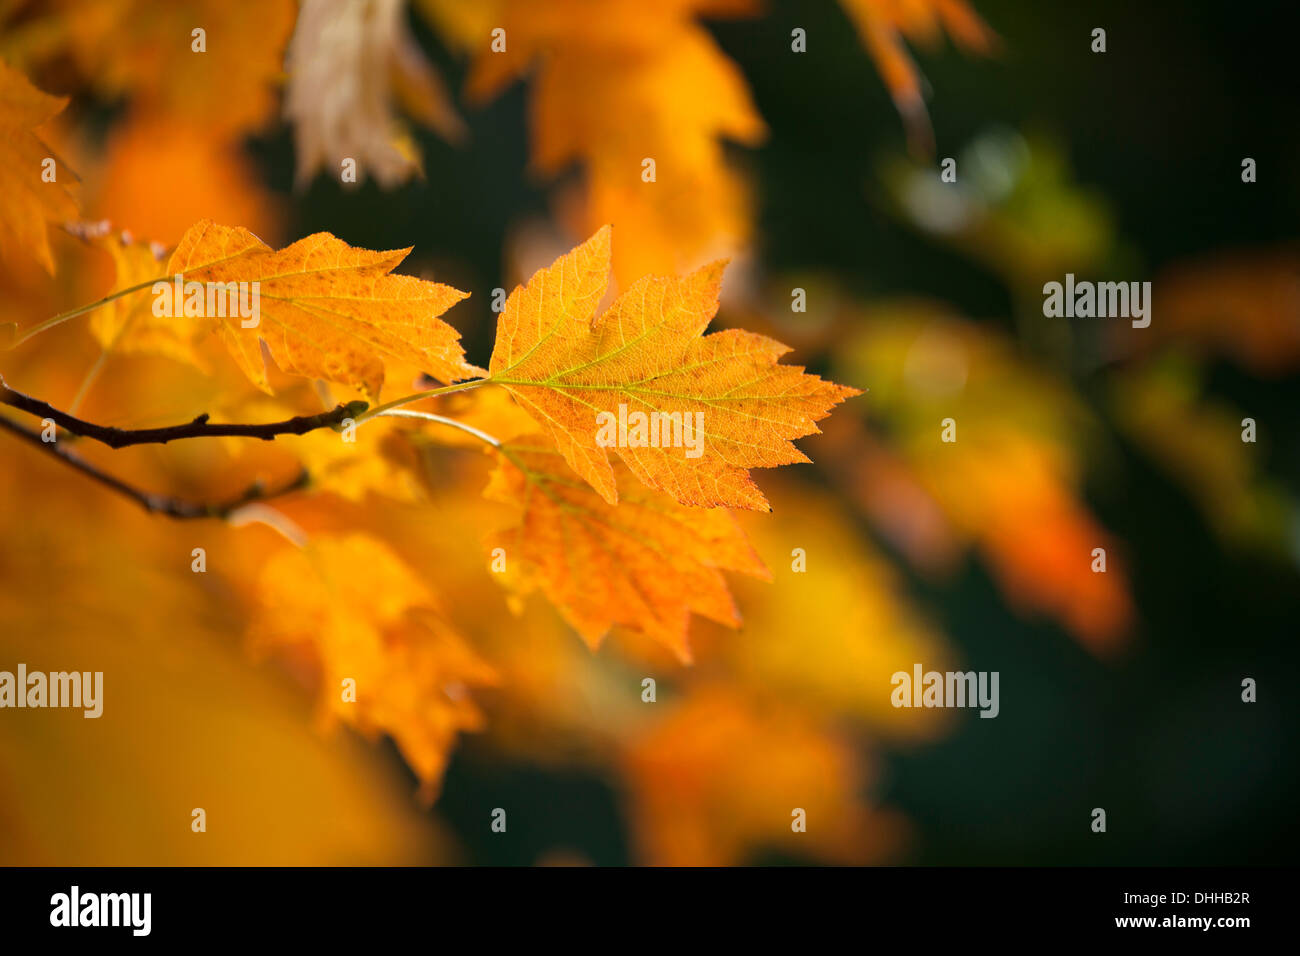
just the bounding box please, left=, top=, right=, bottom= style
left=431, top=0, right=767, bottom=284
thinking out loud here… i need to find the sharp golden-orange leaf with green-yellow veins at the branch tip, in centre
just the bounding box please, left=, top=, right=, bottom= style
left=489, top=228, right=858, bottom=510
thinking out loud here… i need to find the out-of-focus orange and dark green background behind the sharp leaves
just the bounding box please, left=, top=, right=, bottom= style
left=0, top=0, right=1300, bottom=864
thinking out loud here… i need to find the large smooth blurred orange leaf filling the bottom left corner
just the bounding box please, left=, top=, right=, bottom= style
left=0, top=478, right=447, bottom=866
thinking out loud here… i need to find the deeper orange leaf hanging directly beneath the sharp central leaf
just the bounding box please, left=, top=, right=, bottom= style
left=485, top=436, right=771, bottom=661
